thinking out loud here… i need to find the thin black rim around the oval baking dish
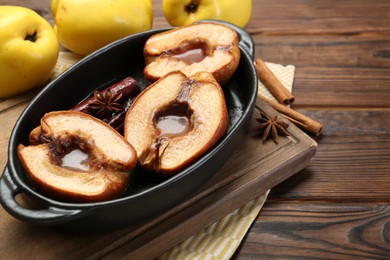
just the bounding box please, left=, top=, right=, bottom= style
left=6, top=20, right=257, bottom=209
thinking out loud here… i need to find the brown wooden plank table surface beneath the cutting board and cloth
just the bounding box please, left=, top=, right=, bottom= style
left=0, top=0, right=390, bottom=259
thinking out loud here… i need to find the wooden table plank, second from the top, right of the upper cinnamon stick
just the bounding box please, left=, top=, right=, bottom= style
left=254, top=35, right=390, bottom=108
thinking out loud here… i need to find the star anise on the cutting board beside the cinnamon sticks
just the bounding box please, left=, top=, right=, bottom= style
left=254, top=112, right=289, bottom=144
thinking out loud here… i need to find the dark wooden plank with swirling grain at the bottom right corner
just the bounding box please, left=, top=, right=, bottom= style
left=235, top=201, right=390, bottom=259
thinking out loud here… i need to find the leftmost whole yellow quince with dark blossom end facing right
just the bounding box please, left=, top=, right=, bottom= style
left=0, top=5, right=59, bottom=98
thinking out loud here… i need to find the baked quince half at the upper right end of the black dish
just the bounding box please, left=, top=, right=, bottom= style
left=144, top=22, right=241, bottom=85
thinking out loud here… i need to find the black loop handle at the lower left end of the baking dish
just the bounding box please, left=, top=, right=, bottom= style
left=0, top=166, right=83, bottom=225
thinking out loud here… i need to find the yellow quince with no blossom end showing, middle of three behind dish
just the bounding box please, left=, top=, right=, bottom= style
left=51, top=0, right=153, bottom=55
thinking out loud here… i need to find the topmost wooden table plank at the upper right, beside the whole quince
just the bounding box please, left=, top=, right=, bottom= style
left=246, top=0, right=390, bottom=36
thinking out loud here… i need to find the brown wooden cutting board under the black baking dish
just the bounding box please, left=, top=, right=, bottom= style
left=0, top=100, right=317, bottom=259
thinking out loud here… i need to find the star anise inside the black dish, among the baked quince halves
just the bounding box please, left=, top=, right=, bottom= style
left=89, top=90, right=124, bottom=119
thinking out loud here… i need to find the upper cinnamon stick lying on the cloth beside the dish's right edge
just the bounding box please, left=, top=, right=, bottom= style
left=255, top=59, right=294, bottom=105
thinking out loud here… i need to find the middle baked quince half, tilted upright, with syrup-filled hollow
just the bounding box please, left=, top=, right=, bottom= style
left=124, top=71, right=228, bottom=176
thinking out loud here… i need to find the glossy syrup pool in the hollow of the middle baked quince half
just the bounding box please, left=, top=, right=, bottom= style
left=156, top=115, right=190, bottom=136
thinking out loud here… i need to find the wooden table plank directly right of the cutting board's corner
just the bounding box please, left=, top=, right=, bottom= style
left=269, top=109, right=390, bottom=202
